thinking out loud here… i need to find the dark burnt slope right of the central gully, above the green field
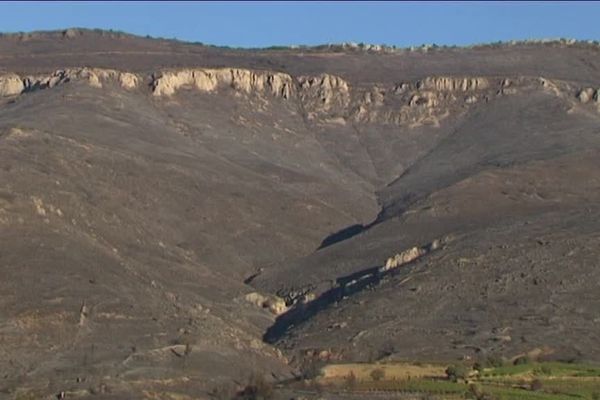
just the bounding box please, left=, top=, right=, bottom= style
left=254, top=89, right=600, bottom=360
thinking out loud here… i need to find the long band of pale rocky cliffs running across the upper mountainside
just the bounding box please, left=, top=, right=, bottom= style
left=0, top=68, right=599, bottom=126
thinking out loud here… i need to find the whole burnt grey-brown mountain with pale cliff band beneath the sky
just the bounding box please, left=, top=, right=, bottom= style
left=0, top=29, right=600, bottom=399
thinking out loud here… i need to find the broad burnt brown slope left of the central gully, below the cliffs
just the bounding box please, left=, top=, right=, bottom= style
left=0, top=74, right=384, bottom=391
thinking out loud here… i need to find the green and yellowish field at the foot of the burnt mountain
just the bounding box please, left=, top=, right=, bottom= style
left=308, top=362, right=600, bottom=400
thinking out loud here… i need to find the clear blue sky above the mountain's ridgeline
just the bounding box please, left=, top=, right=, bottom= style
left=0, top=2, right=600, bottom=47
